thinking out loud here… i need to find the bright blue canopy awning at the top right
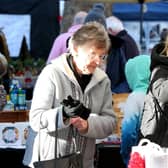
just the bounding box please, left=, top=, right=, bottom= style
left=112, top=2, right=168, bottom=21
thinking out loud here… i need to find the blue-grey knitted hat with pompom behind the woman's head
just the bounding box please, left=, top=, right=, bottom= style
left=84, top=3, right=107, bottom=28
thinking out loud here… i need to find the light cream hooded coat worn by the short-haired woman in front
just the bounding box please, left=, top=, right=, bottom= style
left=23, top=55, right=116, bottom=168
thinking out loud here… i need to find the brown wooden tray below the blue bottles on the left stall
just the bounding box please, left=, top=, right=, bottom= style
left=0, top=110, right=29, bottom=122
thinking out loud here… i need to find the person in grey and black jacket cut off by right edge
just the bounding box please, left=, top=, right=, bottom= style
left=140, top=25, right=168, bottom=148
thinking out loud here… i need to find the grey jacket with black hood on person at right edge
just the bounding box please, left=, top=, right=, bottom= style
left=140, top=44, right=168, bottom=137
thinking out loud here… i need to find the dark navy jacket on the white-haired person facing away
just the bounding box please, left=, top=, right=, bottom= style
left=106, top=30, right=139, bottom=93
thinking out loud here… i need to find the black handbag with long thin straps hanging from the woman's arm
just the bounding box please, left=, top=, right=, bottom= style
left=33, top=115, right=83, bottom=168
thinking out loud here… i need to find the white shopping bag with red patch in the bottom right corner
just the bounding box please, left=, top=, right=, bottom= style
left=128, top=139, right=168, bottom=168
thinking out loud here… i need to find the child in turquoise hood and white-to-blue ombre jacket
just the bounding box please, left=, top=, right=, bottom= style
left=120, top=55, right=151, bottom=165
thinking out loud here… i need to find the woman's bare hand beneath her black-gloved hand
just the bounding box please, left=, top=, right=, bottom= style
left=70, top=117, right=88, bottom=134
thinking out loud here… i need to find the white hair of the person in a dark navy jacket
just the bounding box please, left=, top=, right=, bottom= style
left=106, top=16, right=124, bottom=34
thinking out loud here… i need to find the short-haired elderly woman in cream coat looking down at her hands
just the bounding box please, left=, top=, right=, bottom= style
left=23, top=22, right=116, bottom=168
